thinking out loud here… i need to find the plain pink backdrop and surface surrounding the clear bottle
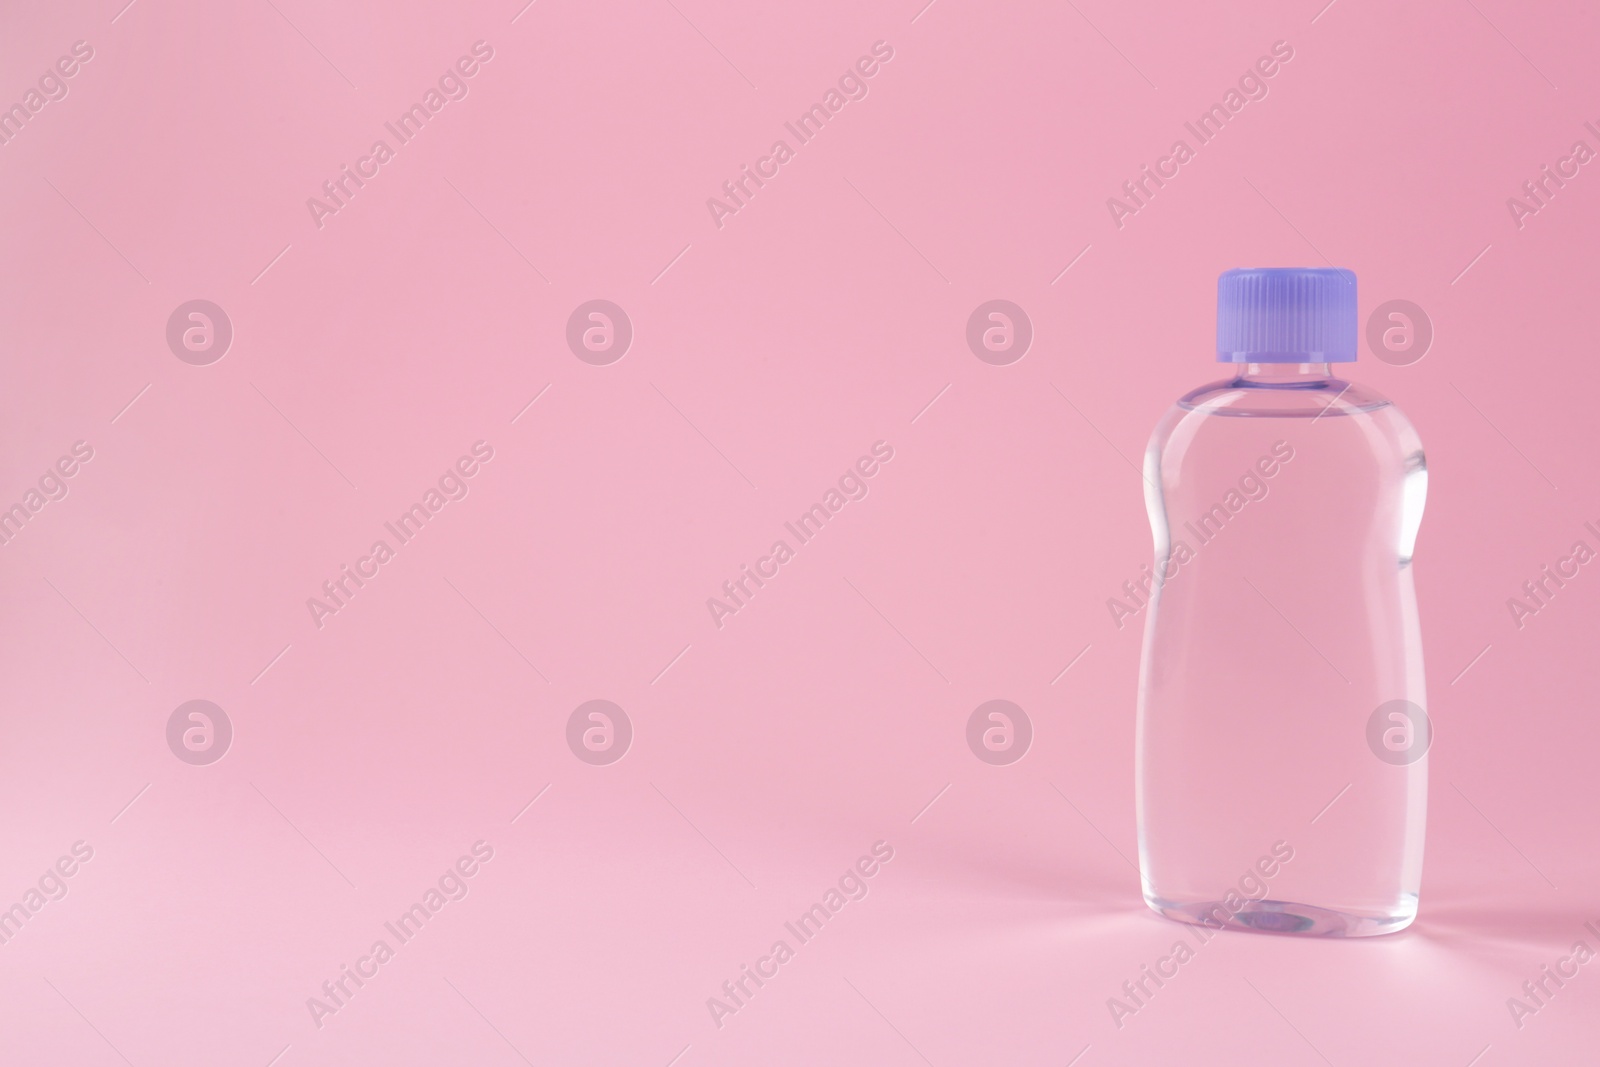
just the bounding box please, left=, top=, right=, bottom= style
left=0, top=0, right=1600, bottom=1067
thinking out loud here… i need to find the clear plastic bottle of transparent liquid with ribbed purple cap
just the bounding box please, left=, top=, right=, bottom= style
left=1134, top=267, right=1430, bottom=937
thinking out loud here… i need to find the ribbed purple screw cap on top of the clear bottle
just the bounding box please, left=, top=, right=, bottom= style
left=1216, top=267, right=1357, bottom=363
